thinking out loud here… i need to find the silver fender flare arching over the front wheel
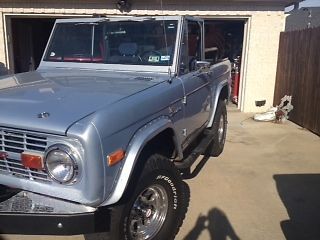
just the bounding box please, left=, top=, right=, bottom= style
left=101, top=116, right=183, bottom=206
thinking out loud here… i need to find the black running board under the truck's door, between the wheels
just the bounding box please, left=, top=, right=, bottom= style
left=175, top=130, right=213, bottom=169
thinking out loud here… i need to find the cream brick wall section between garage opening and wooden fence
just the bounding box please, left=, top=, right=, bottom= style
left=243, top=12, right=285, bottom=112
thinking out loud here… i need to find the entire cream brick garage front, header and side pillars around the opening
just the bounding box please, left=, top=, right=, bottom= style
left=0, top=0, right=285, bottom=112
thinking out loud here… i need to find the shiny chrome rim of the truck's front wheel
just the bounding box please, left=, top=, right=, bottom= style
left=129, top=185, right=168, bottom=239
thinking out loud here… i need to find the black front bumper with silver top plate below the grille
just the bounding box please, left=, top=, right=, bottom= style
left=0, top=189, right=111, bottom=235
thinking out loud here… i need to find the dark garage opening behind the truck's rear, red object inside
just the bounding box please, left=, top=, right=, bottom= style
left=205, top=19, right=246, bottom=105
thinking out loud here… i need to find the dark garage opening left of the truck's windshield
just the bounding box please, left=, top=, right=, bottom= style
left=11, top=17, right=56, bottom=73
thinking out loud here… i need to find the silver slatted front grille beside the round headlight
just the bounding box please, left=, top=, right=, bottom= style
left=0, top=127, right=51, bottom=182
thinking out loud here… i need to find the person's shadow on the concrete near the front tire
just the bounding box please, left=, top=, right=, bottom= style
left=183, top=208, right=240, bottom=240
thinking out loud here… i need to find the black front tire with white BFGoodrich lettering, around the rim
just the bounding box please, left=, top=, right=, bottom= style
left=119, top=154, right=189, bottom=240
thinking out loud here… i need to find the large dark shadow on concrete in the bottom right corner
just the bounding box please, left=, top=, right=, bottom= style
left=274, top=174, right=320, bottom=240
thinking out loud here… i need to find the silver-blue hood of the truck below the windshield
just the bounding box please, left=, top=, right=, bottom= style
left=0, top=70, right=164, bottom=134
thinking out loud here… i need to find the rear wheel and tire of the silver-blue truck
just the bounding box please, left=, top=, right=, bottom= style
left=206, top=100, right=228, bottom=157
